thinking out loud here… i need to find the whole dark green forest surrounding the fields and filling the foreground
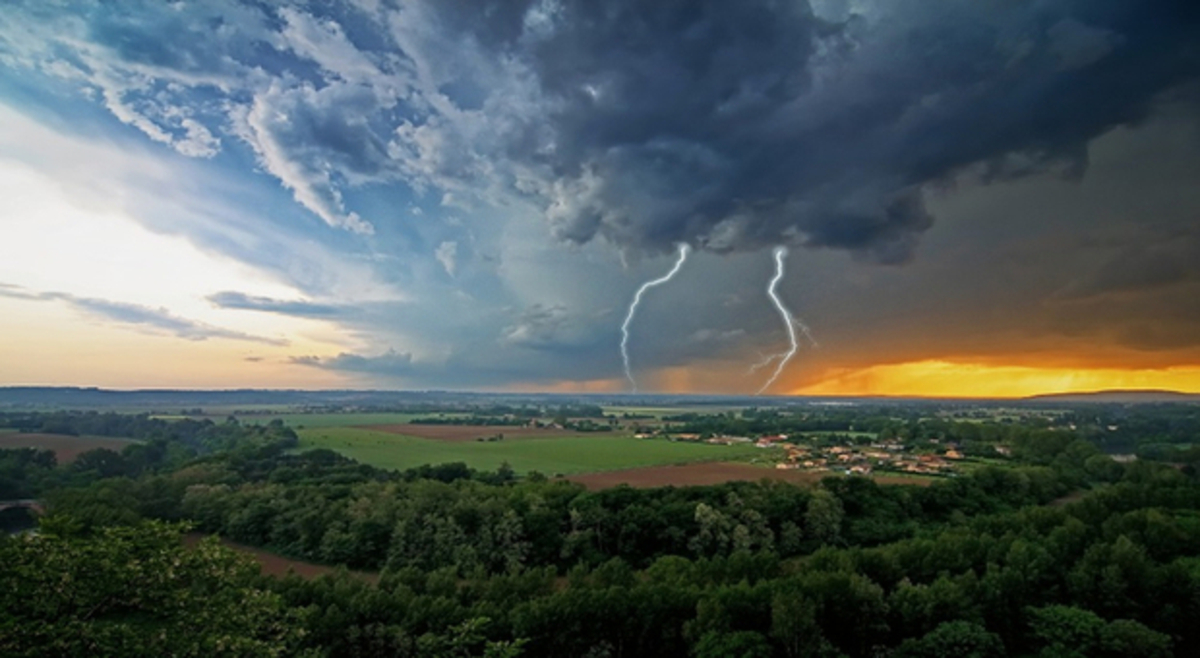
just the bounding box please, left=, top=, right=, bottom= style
left=0, top=406, right=1200, bottom=658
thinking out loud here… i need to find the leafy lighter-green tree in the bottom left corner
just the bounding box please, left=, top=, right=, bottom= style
left=0, top=522, right=314, bottom=658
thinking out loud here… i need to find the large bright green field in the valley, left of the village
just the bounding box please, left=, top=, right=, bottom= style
left=298, top=427, right=764, bottom=475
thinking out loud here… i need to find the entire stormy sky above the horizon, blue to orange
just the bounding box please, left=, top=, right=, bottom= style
left=0, top=0, right=1200, bottom=396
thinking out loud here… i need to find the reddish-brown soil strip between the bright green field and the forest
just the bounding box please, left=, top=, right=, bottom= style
left=566, top=462, right=931, bottom=491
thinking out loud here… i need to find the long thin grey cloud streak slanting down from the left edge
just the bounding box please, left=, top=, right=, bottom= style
left=0, top=283, right=288, bottom=345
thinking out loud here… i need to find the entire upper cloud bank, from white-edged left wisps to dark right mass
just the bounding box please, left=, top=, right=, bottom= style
left=12, top=0, right=1200, bottom=263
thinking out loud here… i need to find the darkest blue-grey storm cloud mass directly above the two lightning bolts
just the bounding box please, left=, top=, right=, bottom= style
left=410, top=0, right=1200, bottom=262
